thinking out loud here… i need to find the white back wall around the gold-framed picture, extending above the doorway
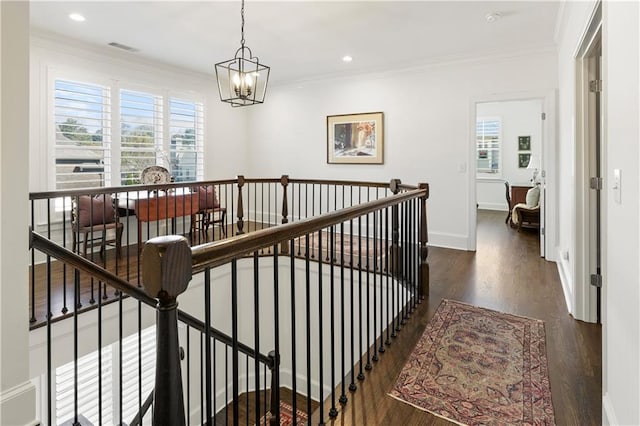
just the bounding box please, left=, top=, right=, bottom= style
left=248, top=52, right=557, bottom=249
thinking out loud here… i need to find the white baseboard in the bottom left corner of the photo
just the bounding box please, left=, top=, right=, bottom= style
left=0, top=381, right=40, bottom=426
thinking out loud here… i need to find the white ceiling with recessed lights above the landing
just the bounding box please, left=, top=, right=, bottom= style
left=31, top=0, right=560, bottom=82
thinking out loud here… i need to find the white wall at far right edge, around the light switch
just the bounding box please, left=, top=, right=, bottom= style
left=602, top=1, right=640, bottom=424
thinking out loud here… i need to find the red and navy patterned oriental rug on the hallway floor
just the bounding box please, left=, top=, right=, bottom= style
left=389, top=299, right=555, bottom=425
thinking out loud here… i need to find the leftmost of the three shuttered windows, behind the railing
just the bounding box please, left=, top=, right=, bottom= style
left=54, top=80, right=111, bottom=189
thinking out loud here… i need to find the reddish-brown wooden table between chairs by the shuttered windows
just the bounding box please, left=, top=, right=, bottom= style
left=131, top=192, right=199, bottom=249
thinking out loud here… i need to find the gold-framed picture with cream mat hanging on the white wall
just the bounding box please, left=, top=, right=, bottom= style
left=327, top=112, right=384, bottom=164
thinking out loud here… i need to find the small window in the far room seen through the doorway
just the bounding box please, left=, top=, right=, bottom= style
left=476, top=117, right=502, bottom=175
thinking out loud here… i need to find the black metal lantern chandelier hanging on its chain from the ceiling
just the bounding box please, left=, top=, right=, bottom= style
left=216, top=0, right=270, bottom=107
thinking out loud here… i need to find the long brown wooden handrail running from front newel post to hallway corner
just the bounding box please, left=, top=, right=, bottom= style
left=191, top=189, right=427, bottom=273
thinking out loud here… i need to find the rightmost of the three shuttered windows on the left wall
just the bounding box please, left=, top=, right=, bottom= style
left=169, top=98, right=204, bottom=182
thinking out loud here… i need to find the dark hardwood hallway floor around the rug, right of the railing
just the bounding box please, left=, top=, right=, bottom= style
left=310, top=211, right=602, bottom=426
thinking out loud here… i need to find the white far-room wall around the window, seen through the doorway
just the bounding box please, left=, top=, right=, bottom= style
left=476, top=100, right=542, bottom=211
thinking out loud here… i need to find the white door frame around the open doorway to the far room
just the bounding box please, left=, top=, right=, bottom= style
left=467, top=90, right=558, bottom=261
